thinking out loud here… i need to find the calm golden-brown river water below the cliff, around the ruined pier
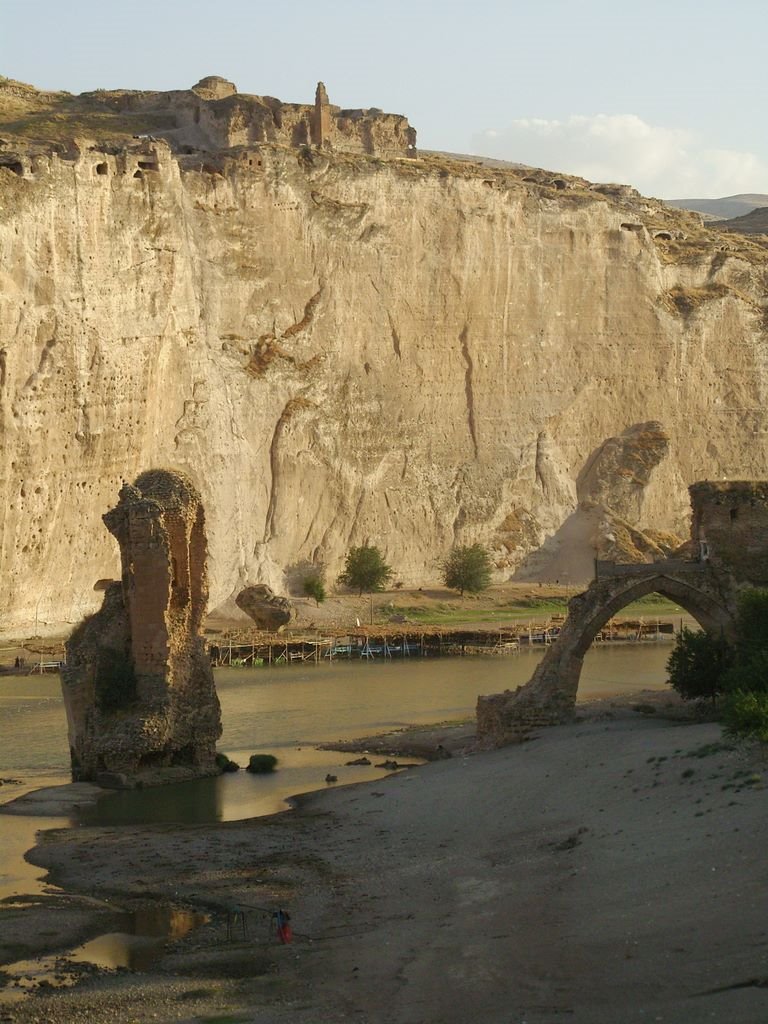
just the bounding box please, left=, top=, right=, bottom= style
left=0, top=641, right=671, bottom=898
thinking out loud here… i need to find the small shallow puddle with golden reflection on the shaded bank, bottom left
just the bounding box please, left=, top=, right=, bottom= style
left=0, top=906, right=208, bottom=1006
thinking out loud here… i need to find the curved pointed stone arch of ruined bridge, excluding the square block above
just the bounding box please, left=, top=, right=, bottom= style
left=477, top=560, right=737, bottom=746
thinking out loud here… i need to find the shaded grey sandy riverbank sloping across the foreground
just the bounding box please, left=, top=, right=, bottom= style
left=0, top=698, right=768, bottom=1024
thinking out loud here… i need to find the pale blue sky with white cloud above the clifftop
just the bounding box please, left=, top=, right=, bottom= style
left=0, top=0, right=768, bottom=199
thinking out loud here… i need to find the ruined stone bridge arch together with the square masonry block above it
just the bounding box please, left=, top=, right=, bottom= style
left=477, top=481, right=768, bottom=746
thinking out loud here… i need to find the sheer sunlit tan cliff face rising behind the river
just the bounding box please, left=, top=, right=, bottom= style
left=0, top=140, right=768, bottom=631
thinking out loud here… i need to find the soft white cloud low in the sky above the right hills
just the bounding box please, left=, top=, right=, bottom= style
left=472, top=114, right=768, bottom=199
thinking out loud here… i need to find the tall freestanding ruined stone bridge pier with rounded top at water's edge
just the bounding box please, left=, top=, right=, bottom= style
left=61, top=470, right=221, bottom=785
